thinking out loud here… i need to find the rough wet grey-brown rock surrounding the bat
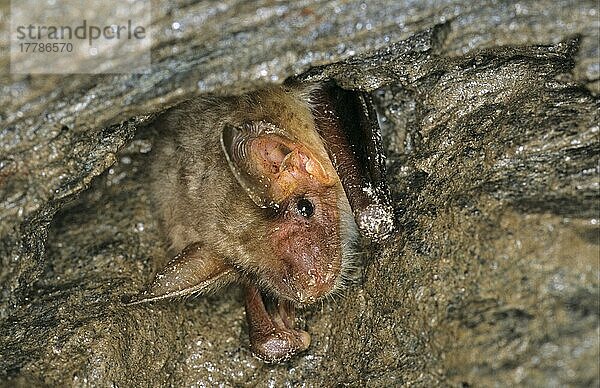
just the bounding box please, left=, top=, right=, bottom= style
left=0, top=1, right=600, bottom=386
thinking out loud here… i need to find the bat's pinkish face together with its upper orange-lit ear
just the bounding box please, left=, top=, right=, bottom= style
left=222, top=117, right=356, bottom=304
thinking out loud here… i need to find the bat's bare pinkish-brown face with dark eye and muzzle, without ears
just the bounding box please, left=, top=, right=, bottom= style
left=262, top=168, right=350, bottom=304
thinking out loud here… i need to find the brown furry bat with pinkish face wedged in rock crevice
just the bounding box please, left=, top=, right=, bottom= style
left=131, top=82, right=394, bottom=363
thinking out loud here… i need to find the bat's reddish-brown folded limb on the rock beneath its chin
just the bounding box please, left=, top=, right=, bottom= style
left=246, top=286, right=310, bottom=363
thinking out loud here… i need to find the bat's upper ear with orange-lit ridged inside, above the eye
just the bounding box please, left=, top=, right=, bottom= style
left=221, top=122, right=335, bottom=209
